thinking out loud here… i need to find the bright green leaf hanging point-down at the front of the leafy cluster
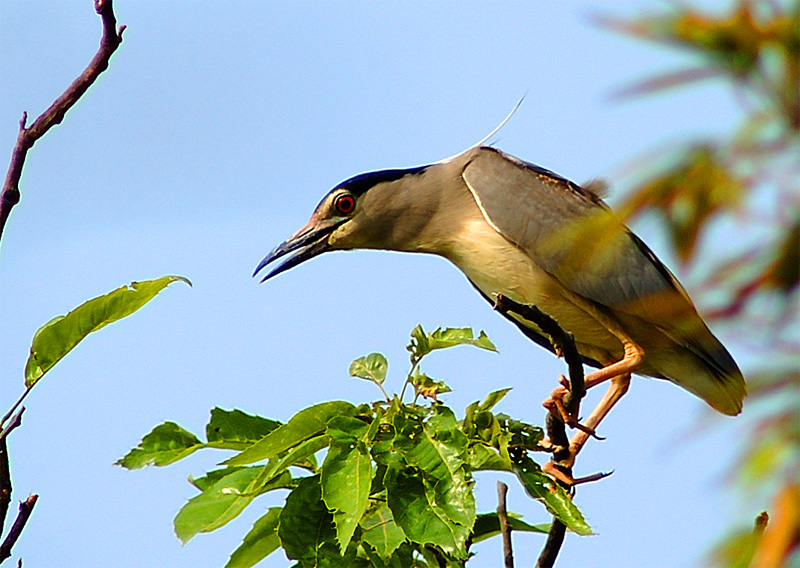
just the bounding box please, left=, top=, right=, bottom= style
left=321, top=440, right=372, bottom=553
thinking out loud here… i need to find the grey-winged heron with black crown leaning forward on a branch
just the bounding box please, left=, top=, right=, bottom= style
left=254, top=136, right=745, bottom=466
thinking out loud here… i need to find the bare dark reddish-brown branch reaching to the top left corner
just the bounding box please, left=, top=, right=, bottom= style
left=0, top=0, right=125, bottom=244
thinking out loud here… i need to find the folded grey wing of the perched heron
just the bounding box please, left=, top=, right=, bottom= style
left=462, top=148, right=689, bottom=312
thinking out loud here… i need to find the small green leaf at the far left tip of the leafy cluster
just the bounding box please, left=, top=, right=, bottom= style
left=114, top=422, right=203, bottom=469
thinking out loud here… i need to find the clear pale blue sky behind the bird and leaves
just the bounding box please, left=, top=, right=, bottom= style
left=0, top=0, right=757, bottom=568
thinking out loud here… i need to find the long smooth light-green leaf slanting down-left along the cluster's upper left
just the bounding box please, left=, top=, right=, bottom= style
left=230, top=400, right=356, bottom=465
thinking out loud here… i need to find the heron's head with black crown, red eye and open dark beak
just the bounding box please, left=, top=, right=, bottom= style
left=253, top=166, right=428, bottom=282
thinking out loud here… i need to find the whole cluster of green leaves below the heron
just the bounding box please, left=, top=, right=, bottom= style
left=117, top=326, right=591, bottom=568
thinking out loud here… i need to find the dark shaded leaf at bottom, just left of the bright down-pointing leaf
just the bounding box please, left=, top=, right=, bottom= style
left=278, top=475, right=355, bottom=568
